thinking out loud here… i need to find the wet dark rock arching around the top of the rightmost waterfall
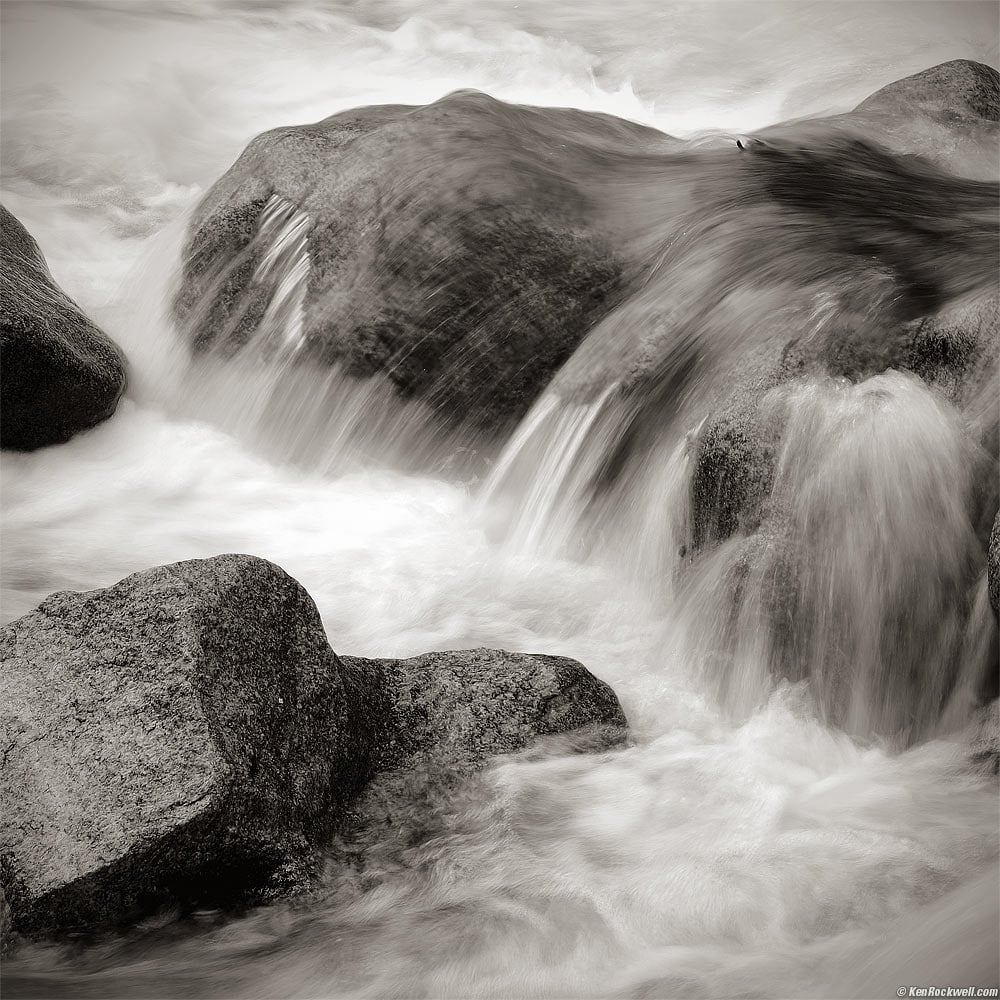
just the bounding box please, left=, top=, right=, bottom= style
left=690, top=290, right=1000, bottom=551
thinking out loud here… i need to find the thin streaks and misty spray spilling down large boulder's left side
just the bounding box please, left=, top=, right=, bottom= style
left=163, top=194, right=481, bottom=475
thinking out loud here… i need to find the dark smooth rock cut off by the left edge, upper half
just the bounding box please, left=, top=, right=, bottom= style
left=0, top=206, right=126, bottom=450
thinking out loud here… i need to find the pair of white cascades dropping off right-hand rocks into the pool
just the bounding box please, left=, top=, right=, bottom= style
left=482, top=360, right=995, bottom=744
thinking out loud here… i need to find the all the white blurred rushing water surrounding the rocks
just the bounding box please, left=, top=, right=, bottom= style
left=2, top=0, right=1000, bottom=997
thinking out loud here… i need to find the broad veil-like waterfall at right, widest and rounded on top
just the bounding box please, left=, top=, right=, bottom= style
left=687, top=371, right=994, bottom=743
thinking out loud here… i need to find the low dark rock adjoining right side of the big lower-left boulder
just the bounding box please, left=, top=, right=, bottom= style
left=336, top=649, right=627, bottom=891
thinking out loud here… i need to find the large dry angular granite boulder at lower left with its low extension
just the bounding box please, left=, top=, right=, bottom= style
left=0, top=555, right=625, bottom=934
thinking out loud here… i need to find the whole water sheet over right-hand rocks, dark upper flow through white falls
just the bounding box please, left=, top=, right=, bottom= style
left=484, top=136, right=996, bottom=745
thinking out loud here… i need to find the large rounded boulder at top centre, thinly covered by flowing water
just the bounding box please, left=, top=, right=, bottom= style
left=176, top=91, right=669, bottom=430
